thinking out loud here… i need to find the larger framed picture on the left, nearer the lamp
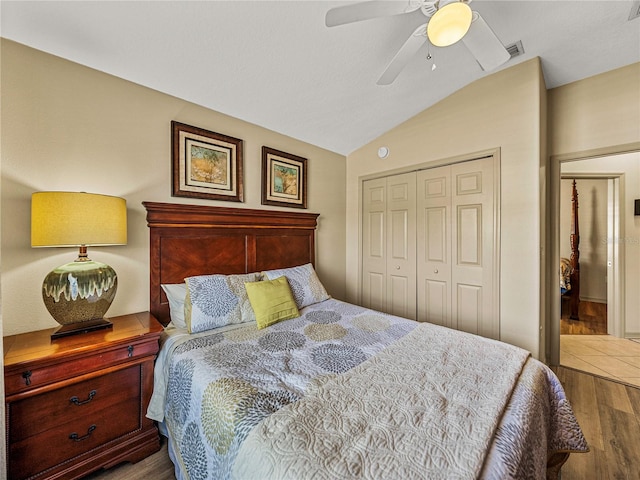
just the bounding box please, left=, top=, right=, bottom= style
left=171, top=122, right=243, bottom=202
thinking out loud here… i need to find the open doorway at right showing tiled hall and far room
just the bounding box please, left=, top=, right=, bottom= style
left=548, top=150, right=640, bottom=385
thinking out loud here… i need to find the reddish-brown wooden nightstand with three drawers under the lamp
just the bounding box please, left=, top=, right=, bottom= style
left=4, top=312, right=162, bottom=480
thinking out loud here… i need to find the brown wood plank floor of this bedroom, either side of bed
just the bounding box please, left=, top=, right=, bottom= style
left=87, top=367, right=640, bottom=480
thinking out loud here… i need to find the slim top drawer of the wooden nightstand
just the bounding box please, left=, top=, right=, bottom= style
left=5, top=341, right=158, bottom=396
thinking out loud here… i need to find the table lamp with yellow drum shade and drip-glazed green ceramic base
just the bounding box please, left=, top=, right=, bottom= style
left=31, top=192, right=127, bottom=339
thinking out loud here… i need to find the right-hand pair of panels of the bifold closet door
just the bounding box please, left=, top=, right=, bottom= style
left=416, top=157, right=499, bottom=338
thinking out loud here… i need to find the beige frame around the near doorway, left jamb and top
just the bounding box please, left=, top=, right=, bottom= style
left=541, top=142, right=640, bottom=366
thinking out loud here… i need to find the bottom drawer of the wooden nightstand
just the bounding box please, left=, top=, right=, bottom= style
left=9, top=398, right=141, bottom=479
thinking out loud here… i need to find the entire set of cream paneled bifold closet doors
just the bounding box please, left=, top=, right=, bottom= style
left=361, top=157, right=500, bottom=338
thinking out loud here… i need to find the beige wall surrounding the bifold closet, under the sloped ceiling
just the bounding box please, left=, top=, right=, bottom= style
left=347, top=59, right=545, bottom=356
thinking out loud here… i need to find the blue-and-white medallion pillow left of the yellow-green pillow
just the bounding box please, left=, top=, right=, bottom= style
left=184, top=273, right=261, bottom=333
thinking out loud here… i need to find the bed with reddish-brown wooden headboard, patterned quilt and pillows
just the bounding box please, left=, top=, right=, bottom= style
left=144, top=202, right=588, bottom=479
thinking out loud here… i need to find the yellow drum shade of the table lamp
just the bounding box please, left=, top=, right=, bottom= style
left=31, top=192, right=127, bottom=247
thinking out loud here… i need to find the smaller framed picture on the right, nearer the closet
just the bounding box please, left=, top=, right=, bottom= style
left=262, top=147, right=307, bottom=208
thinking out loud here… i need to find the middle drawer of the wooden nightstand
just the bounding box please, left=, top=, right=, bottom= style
left=8, top=365, right=141, bottom=442
